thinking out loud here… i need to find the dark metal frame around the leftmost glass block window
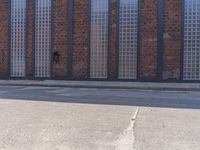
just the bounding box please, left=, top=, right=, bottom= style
left=8, top=0, right=29, bottom=79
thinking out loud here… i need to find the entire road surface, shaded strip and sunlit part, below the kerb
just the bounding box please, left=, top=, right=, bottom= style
left=0, top=86, right=200, bottom=150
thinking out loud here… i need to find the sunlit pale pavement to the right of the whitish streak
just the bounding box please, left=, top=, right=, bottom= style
left=134, top=107, right=200, bottom=150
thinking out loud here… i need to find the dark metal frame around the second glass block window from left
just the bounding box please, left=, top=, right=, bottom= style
left=32, top=0, right=54, bottom=79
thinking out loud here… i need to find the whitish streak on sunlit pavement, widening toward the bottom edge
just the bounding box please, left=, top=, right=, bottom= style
left=116, top=107, right=139, bottom=150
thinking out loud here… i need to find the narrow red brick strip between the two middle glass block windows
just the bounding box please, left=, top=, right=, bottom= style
left=109, top=0, right=118, bottom=79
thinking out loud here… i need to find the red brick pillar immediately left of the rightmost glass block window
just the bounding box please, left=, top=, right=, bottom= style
left=163, top=0, right=182, bottom=80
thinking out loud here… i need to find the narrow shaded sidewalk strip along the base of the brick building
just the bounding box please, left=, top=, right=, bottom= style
left=0, top=80, right=200, bottom=91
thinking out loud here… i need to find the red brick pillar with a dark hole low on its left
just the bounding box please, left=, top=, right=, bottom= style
left=52, top=0, right=68, bottom=79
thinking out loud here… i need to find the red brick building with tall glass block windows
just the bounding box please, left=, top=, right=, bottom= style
left=0, top=0, right=200, bottom=82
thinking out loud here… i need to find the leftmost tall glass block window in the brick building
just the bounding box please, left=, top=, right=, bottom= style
left=10, top=0, right=27, bottom=77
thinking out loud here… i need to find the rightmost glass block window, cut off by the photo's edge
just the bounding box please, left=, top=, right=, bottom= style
left=183, top=0, right=200, bottom=80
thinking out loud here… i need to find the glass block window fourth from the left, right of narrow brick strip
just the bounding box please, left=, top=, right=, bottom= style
left=119, top=0, right=138, bottom=79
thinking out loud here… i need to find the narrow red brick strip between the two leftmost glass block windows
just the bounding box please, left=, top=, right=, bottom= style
left=26, top=0, right=34, bottom=79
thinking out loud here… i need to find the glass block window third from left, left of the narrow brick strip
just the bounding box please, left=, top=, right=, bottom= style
left=90, top=0, right=109, bottom=78
